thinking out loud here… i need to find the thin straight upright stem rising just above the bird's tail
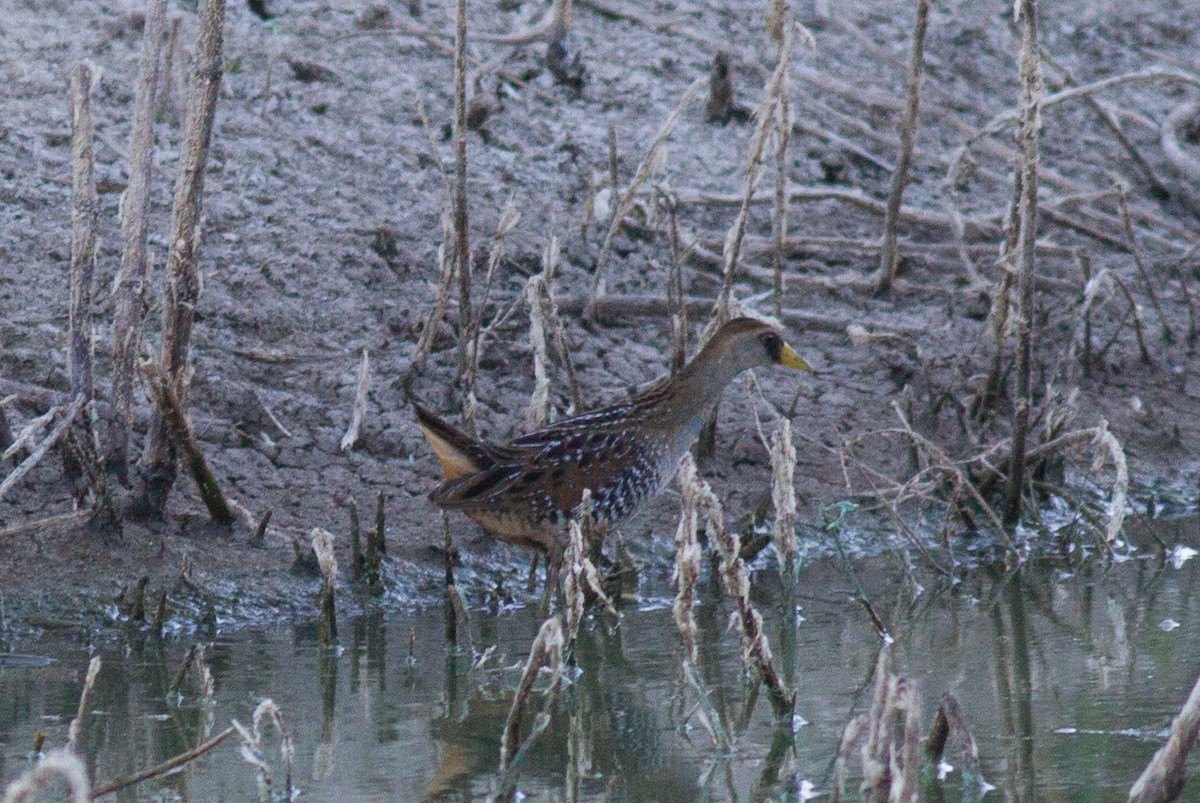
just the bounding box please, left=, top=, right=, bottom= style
left=454, top=0, right=475, bottom=377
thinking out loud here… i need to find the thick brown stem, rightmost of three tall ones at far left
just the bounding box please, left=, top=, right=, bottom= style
left=138, top=0, right=224, bottom=516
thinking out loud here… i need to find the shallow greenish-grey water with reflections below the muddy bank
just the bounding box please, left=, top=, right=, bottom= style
left=0, top=522, right=1200, bottom=801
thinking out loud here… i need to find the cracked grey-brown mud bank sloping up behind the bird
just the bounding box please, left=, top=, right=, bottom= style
left=0, top=0, right=1200, bottom=609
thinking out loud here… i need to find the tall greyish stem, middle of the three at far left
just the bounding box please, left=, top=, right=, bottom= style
left=104, top=0, right=166, bottom=485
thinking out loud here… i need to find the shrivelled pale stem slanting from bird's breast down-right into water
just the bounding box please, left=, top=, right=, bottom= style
left=680, top=455, right=794, bottom=719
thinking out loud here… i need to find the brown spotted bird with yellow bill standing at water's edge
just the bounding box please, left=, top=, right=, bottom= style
left=413, top=318, right=810, bottom=559
